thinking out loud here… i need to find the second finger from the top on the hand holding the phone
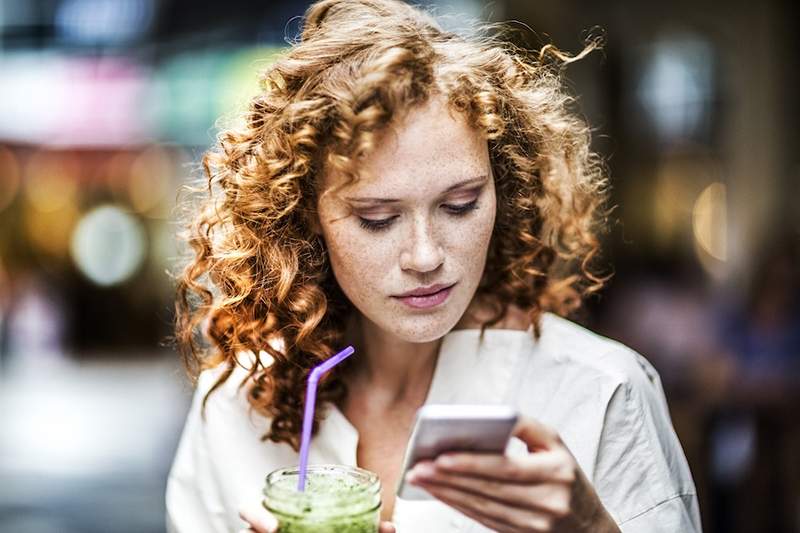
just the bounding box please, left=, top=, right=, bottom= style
left=407, top=461, right=569, bottom=513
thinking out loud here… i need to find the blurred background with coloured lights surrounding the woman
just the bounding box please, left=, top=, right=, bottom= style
left=0, top=0, right=800, bottom=533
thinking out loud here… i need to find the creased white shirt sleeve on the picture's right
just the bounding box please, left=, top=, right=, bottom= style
left=592, top=352, right=702, bottom=533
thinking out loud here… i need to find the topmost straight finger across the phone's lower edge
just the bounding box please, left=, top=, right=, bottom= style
left=435, top=452, right=563, bottom=483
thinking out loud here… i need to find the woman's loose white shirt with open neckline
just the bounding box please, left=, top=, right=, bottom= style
left=166, top=314, right=701, bottom=533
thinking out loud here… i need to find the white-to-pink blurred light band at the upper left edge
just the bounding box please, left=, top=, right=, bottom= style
left=0, top=52, right=155, bottom=146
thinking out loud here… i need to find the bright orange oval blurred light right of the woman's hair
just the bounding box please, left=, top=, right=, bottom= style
left=692, top=183, right=728, bottom=261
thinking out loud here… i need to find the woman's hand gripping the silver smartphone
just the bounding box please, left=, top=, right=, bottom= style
left=406, top=418, right=619, bottom=533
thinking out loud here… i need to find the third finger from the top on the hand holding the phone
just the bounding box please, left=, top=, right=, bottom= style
left=421, top=483, right=552, bottom=531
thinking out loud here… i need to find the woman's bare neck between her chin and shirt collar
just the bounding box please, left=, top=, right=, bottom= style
left=350, top=315, right=442, bottom=408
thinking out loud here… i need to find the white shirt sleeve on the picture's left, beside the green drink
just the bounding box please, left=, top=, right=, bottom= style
left=166, top=372, right=229, bottom=533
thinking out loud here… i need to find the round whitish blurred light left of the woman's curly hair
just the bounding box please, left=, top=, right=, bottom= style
left=71, top=205, right=145, bottom=287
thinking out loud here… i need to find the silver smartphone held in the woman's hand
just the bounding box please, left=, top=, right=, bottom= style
left=397, top=404, right=518, bottom=500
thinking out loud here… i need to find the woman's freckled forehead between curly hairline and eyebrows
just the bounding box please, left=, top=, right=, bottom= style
left=325, top=99, right=489, bottom=198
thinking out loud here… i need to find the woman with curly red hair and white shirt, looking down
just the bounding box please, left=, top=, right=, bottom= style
left=167, top=0, right=700, bottom=533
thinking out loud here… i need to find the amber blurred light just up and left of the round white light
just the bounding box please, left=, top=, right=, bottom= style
left=25, top=151, right=79, bottom=212
